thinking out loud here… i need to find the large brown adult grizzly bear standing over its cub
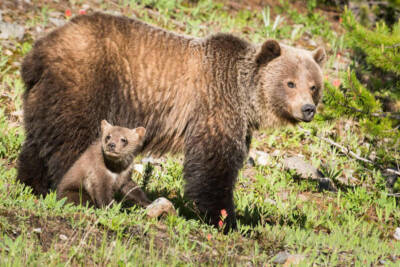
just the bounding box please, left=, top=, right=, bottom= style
left=18, top=13, right=325, bottom=230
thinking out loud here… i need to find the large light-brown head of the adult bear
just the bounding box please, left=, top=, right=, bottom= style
left=255, top=40, right=326, bottom=126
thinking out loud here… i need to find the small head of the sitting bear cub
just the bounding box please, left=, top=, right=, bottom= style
left=101, top=120, right=146, bottom=160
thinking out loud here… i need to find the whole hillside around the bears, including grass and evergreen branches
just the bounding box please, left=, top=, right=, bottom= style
left=0, top=0, right=400, bottom=266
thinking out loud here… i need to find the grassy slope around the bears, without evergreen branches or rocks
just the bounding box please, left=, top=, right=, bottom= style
left=0, top=0, right=400, bottom=266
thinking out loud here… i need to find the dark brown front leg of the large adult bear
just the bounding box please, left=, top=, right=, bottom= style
left=184, top=125, right=247, bottom=233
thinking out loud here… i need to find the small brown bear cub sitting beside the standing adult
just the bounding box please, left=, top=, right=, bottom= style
left=57, top=120, right=150, bottom=208
